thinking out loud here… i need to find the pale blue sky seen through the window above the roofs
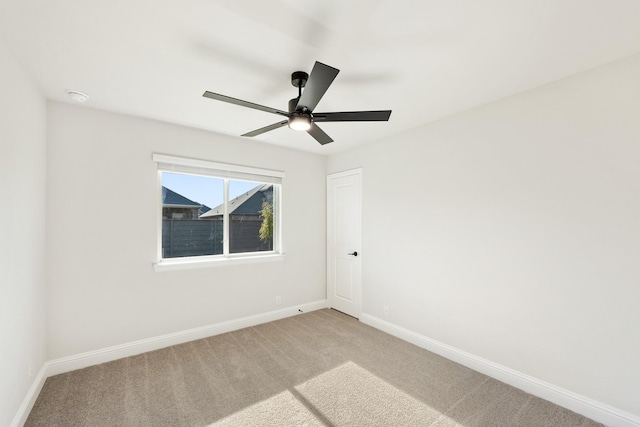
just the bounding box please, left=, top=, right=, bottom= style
left=162, top=172, right=262, bottom=208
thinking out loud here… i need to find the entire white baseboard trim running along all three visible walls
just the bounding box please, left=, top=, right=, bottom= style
left=22, top=300, right=640, bottom=427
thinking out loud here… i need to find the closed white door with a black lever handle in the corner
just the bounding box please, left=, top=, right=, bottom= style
left=327, top=169, right=362, bottom=318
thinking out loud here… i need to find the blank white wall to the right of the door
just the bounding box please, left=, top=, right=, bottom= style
left=328, top=56, right=640, bottom=415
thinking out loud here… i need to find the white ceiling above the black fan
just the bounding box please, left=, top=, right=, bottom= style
left=0, top=0, right=640, bottom=154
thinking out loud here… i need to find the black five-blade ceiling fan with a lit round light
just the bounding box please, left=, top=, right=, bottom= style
left=202, top=61, right=391, bottom=145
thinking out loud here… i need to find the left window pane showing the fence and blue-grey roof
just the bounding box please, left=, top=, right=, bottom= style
left=162, top=172, right=224, bottom=258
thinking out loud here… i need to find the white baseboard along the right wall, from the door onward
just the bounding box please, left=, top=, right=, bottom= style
left=360, top=314, right=640, bottom=427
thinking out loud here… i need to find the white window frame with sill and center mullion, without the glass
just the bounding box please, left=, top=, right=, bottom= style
left=152, top=153, right=285, bottom=271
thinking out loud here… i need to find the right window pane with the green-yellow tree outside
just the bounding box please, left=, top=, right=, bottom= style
left=229, top=181, right=274, bottom=253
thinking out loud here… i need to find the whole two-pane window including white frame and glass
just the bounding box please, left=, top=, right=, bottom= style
left=153, top=154, right=284, bottom=270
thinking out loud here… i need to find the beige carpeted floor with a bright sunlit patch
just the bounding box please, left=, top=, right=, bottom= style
left=25, top=309, right=600, bottom=427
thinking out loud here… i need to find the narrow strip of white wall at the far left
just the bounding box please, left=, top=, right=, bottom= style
left=0, top=37, right=46, bottom=426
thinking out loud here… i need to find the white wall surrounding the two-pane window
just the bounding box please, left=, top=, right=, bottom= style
left=47, top=103, right=326, bottom=359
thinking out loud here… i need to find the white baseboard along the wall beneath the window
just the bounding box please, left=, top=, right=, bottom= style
left=46, top=300, right=328, bottom=377
